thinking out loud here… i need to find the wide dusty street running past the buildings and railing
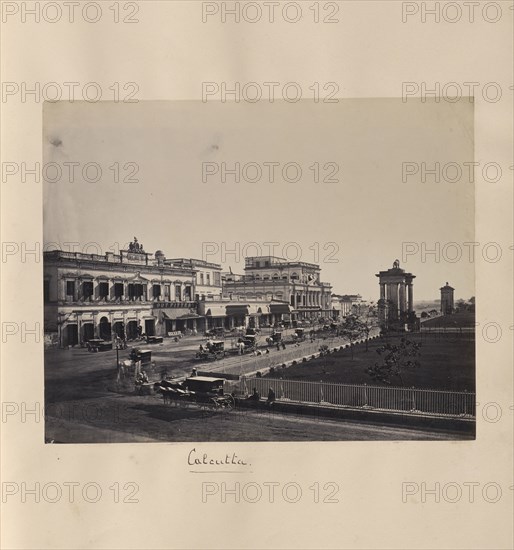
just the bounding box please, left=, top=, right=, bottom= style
left=45, top=330, right=464, bottom=443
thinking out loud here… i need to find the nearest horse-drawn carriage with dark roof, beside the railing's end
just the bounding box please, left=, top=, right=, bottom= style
left=154, top=376, right=235, bottom=409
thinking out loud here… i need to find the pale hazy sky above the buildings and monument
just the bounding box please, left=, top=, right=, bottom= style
left=43, top=99, right=475, bottom=300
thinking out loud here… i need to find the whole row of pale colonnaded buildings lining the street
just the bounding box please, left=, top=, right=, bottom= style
left=43, top=239, right=370, bottom=347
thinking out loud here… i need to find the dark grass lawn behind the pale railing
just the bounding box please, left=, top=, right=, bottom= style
left=266, top=333, right=475, bottom=391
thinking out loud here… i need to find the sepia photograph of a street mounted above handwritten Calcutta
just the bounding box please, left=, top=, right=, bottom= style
left=42, top=99, right=476, bottom=443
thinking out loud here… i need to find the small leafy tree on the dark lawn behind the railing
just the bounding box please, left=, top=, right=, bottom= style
left=366, top=338, right=421, bottom=386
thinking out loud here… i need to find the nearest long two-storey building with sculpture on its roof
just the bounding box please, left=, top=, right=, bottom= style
left=44, top=241, right=199, bottom=347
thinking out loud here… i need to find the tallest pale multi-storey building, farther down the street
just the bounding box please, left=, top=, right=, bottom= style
left=222, top=256, right=332, bottom=321
